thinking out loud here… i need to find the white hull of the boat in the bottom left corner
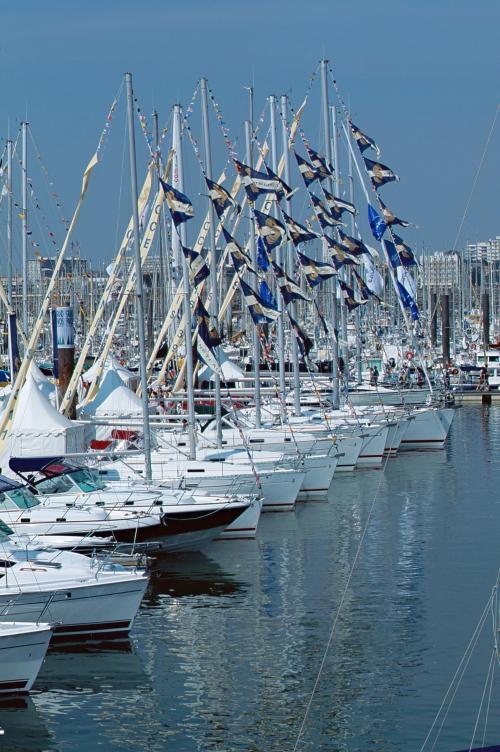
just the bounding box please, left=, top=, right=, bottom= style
left=0, top=617, right=52, bottom=695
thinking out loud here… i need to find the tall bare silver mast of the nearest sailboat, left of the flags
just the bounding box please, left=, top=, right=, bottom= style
left=125, top=73, right=151, bottom=481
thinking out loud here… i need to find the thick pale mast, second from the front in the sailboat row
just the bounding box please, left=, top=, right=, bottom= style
left=172, top=104, right=196, bottom=460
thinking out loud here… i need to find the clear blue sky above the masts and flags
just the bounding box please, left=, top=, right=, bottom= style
left=0, top=0, right=500, bottom=270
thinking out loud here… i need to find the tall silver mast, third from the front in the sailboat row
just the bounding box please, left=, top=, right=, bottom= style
left=201, top=78, right=222, bottom=449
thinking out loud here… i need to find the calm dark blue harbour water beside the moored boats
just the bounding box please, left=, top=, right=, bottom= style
left=0, top=407, right=500, bottom=752
